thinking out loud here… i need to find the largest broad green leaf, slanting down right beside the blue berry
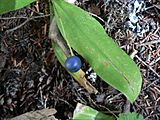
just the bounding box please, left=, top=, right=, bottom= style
left=53, top=0, right=142, bottom=102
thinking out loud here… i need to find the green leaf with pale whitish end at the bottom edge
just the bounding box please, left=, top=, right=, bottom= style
left=73, top=103, right=115, bottom=120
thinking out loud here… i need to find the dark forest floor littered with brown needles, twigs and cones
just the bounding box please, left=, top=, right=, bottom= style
left=0, top=0, right=160, bottom=120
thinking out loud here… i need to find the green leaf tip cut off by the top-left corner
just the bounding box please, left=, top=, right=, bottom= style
left=0, top=0, right=36, bottom=14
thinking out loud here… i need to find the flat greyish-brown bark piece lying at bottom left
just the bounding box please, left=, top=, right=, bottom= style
left=8, top=108, right=58, bottom=120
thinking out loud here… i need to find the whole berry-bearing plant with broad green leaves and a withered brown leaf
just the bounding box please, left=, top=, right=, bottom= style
left=0, top=0, right=142, bottom=102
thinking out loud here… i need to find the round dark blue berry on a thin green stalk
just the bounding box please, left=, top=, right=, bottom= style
left=64, top=56, right=82, bottom=72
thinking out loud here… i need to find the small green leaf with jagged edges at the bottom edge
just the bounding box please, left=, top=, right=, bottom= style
left=117, top=112, right=144, bottom=120
